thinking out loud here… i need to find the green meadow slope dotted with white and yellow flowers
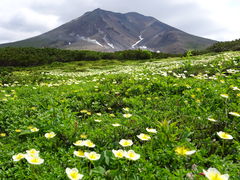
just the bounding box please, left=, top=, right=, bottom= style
left=0, top=52, right=240, bottom=180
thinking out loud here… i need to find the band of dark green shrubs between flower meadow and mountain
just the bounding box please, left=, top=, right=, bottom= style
left=0, top=47, right=181, bottom=66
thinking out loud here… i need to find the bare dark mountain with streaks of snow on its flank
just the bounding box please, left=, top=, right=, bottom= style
left=0, top=9, right=216, bottom=53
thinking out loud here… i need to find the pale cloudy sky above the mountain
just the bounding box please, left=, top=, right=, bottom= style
left=0, top=0, right=240, bottom=43
